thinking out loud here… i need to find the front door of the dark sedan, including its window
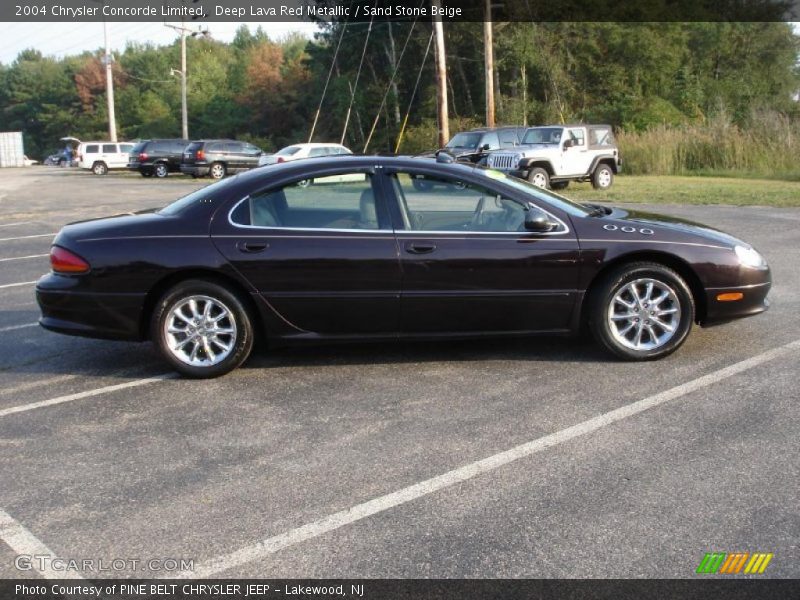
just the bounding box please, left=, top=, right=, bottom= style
left=388, top=171, right=578, bottom=335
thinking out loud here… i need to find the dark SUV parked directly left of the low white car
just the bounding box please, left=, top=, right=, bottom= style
left=181, top=140, right=263, bottom=179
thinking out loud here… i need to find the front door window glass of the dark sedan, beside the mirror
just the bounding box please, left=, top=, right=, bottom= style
left=392, top=173, right=525, bottom=233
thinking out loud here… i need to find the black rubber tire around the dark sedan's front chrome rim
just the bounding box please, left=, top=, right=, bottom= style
left=587, top=262, right=695, bottom=361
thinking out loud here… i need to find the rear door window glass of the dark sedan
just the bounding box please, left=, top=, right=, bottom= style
left=231, top=172, right=388, bottom=230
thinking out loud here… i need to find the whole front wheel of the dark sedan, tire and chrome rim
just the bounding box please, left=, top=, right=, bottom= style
left=589, top=263, right=695, bottom=360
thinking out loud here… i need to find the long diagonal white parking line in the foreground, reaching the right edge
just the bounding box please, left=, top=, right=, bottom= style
left=175, top=340, right=800, bottom=578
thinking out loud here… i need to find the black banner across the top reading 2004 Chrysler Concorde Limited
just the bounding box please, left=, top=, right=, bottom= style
left=0, top=0, right=800, bottom=22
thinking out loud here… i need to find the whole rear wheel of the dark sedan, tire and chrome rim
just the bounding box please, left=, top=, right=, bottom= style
left=151, top=280, right=253, bottom=379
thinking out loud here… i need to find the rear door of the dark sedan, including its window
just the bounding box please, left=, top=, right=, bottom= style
left=212, top=170, right=400, bottom=337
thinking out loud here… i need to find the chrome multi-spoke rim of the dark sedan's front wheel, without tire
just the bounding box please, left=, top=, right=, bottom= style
left=607, top=278, right=681, bottom=351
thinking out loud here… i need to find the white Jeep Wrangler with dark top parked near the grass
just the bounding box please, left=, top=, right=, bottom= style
left=486, top=125, right=622, bottom=190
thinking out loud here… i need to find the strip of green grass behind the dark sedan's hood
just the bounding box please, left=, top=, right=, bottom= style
left=559, top=175, right=800, bottom=207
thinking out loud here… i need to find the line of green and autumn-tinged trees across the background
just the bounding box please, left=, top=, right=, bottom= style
left=0, top=21, right=800, bottom=157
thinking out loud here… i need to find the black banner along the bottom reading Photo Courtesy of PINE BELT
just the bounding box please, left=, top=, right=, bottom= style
left=0, top=579, right=800, bottom=600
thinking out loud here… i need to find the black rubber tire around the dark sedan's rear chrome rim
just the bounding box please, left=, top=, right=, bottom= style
left=150, top=279, right=254, bottom=379
